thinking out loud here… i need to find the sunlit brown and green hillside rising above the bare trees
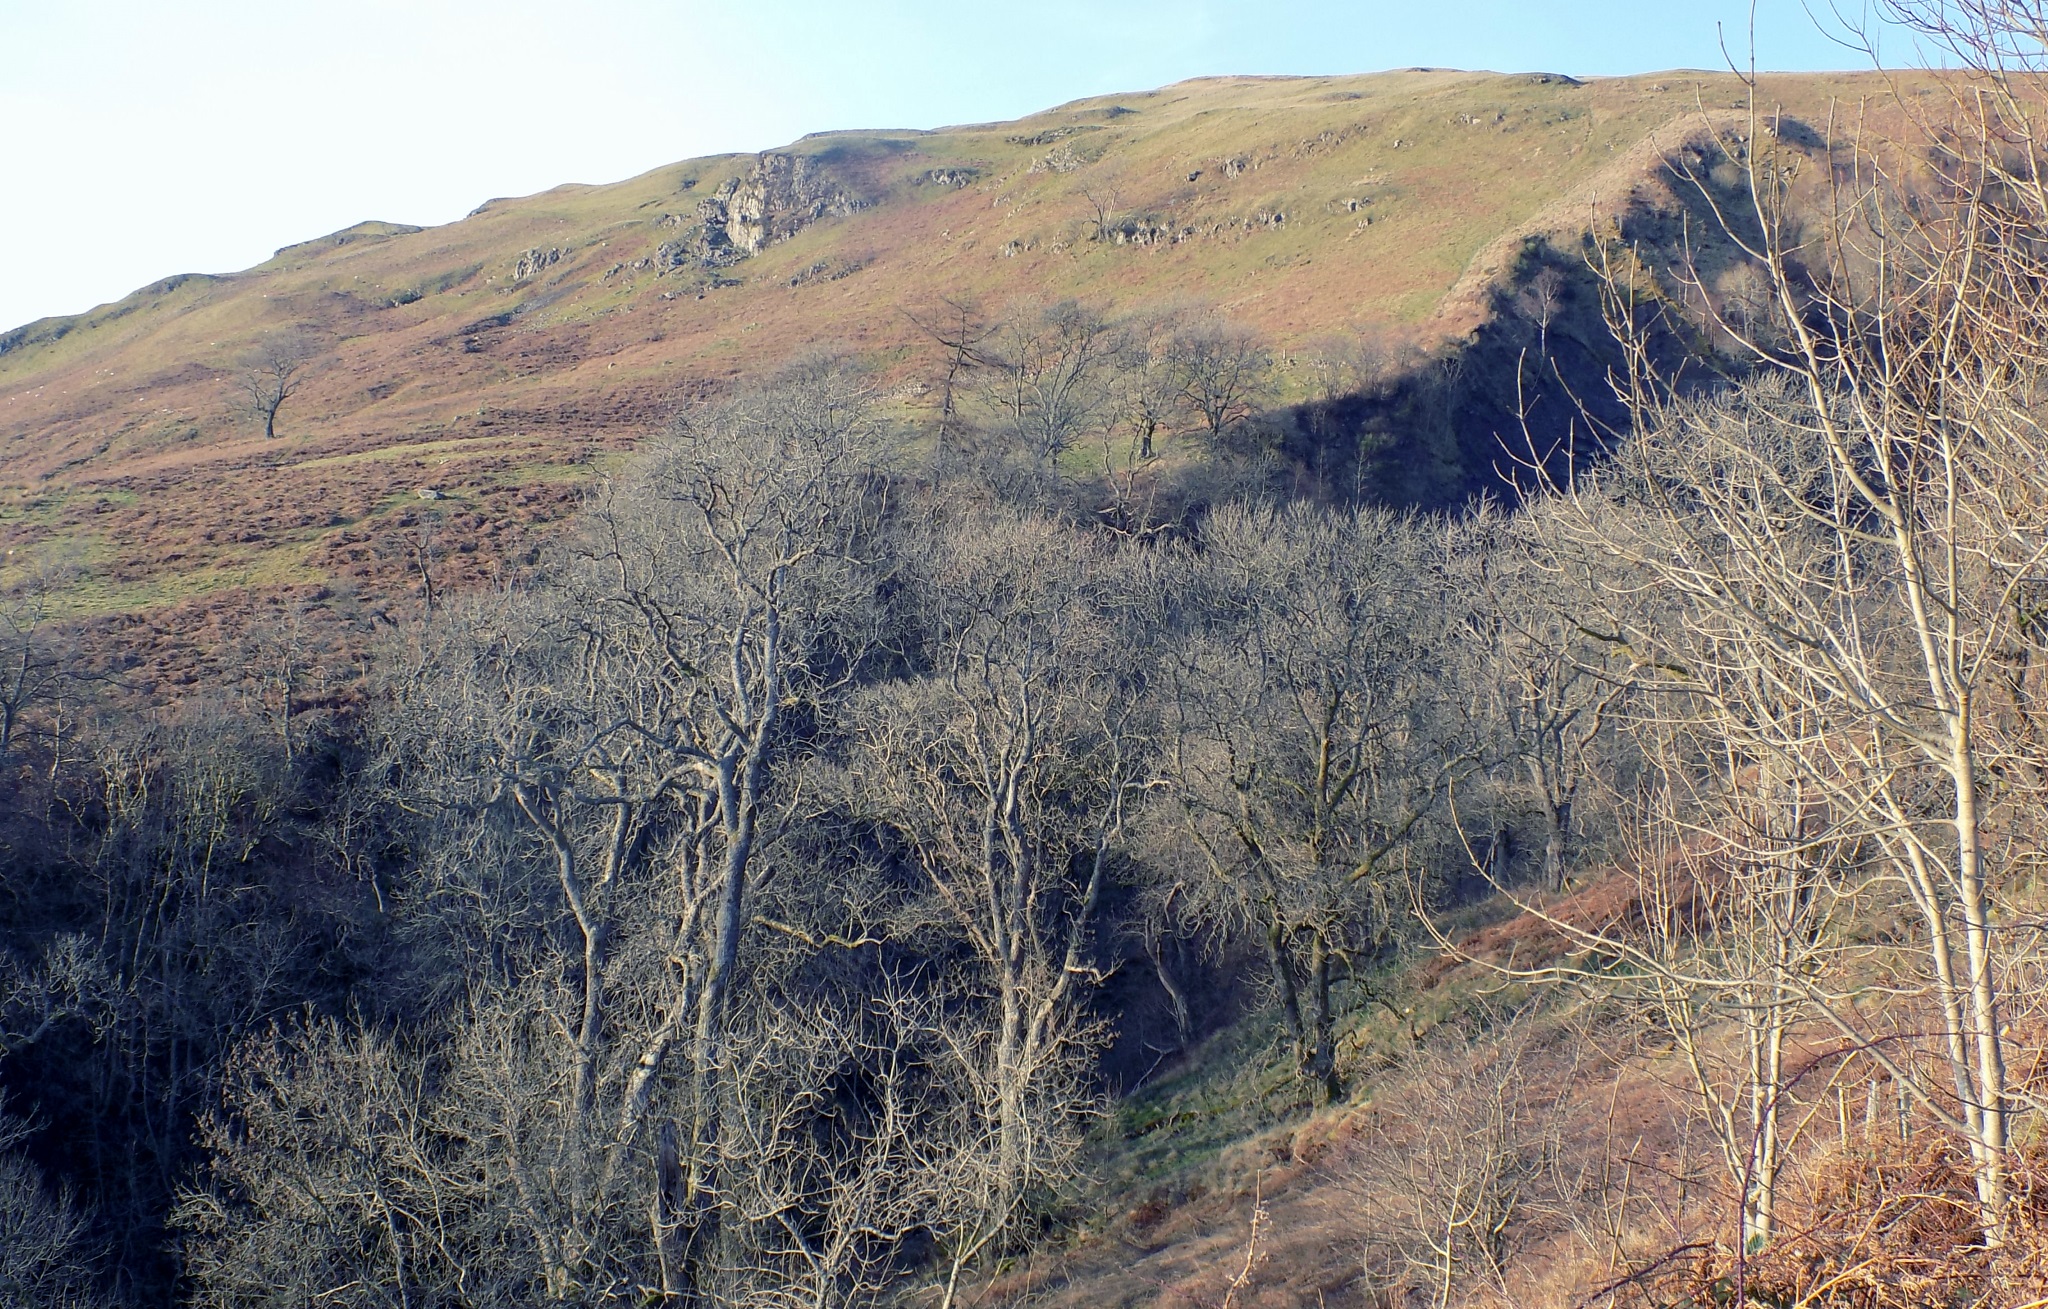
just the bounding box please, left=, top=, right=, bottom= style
left=0, top=70, right=1860, bottom=690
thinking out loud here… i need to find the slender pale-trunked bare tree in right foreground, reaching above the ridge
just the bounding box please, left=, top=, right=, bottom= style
left=1482, top=4, right=2048, bottom=1248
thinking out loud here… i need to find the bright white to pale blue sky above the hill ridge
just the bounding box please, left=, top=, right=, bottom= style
left=0, top=0, right=1900, bottom=330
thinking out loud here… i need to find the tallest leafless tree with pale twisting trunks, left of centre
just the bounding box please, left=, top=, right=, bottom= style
left=329, top=365, right=883, bottom=1299
